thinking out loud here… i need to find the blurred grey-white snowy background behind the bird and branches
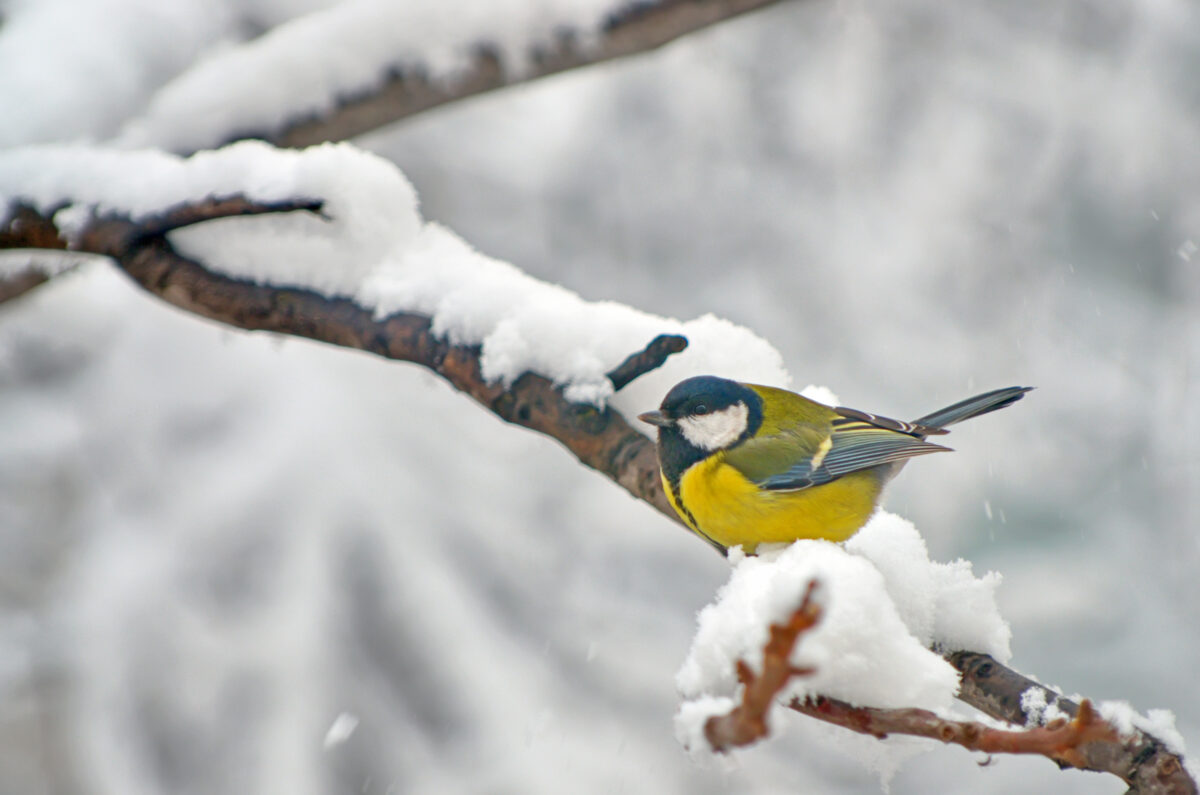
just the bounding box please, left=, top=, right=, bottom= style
left=0, top=0, right=1200, bottom=795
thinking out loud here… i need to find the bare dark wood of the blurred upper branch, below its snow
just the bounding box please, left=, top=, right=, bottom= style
left=268, top=0, right=780, bottom=147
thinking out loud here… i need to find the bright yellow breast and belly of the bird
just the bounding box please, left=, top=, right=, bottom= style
left=664, top=453, right=882, bottom=552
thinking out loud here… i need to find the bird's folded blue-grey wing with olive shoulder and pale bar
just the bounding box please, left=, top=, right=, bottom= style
left=726, top=417, right=949, bottom=491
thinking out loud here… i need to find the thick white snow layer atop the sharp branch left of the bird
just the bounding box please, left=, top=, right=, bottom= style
left=0, top=142, right=788, bottom=412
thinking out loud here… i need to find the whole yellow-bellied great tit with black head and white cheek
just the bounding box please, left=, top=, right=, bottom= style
left=638, top=376, right=1033, bottom=554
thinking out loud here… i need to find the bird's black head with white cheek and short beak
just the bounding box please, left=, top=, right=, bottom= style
left=637, top=376, right=762, bottom=453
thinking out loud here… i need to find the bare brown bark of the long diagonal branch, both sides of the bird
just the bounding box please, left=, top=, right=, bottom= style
left=0, top=196, right=1196, bottom=794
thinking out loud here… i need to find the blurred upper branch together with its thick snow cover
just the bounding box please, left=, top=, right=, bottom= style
left=110, top=0, right=796, bottom=153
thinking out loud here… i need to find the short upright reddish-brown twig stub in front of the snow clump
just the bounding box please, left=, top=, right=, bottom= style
left=704, top=580, right=821, bottom=752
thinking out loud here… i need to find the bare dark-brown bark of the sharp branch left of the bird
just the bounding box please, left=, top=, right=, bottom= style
left=0, top=196, right=685, bottom=528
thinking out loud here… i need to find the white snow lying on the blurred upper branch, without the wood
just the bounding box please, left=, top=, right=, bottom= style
left=116, top=0, right=638, bottom=151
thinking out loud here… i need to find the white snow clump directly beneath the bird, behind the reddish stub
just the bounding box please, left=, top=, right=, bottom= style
left=676, top=510, right=1010, bottom=769
